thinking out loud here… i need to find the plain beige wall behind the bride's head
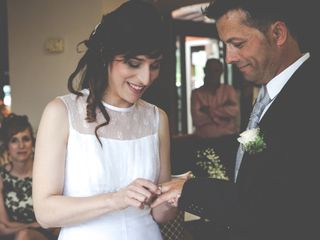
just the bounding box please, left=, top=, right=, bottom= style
left=7, top=0, right=125, bottom=131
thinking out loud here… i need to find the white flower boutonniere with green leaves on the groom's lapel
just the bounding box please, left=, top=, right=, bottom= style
left=238, top=128, right=267, bottom=154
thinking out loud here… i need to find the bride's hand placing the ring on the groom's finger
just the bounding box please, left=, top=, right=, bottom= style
left=114, top=178, right=159, bottom=209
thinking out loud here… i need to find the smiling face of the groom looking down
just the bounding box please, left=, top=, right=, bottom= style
left=217, top=10, right=277, bottom=84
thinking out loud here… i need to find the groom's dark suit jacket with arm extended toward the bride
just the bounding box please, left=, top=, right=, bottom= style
left=179, top=56, right=320, bottom=240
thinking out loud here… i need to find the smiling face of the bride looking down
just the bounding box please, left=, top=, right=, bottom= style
left=103, top=55, right=161, bottom=107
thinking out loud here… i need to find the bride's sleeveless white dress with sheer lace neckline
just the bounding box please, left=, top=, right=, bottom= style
left=59, top=90, right=162, bottom=240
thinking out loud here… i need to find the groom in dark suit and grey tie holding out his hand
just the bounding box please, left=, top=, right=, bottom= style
left=152, top=0, right=320, bottom=240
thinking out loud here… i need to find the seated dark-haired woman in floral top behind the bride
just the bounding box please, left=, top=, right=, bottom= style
left=0, top=114, right=57, bottom=240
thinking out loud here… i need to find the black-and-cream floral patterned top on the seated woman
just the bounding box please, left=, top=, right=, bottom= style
left=0, top=166, right=35, bottom=223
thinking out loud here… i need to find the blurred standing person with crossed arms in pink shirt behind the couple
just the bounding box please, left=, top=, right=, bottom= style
left=191, top=58, right=240, bottom=138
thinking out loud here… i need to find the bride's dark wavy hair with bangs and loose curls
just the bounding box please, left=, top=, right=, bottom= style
left=68, top=0, right=168, bottom=144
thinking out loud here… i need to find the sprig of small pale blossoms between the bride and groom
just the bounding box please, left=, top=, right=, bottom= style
left=196, top=148, right=229, bottom=180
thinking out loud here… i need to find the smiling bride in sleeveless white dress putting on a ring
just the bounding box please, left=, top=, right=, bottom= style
left=33, top=1, right=176, bottom=240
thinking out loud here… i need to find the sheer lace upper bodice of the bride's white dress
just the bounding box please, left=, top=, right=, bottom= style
left=62, top=90, right=159, bottom=140
